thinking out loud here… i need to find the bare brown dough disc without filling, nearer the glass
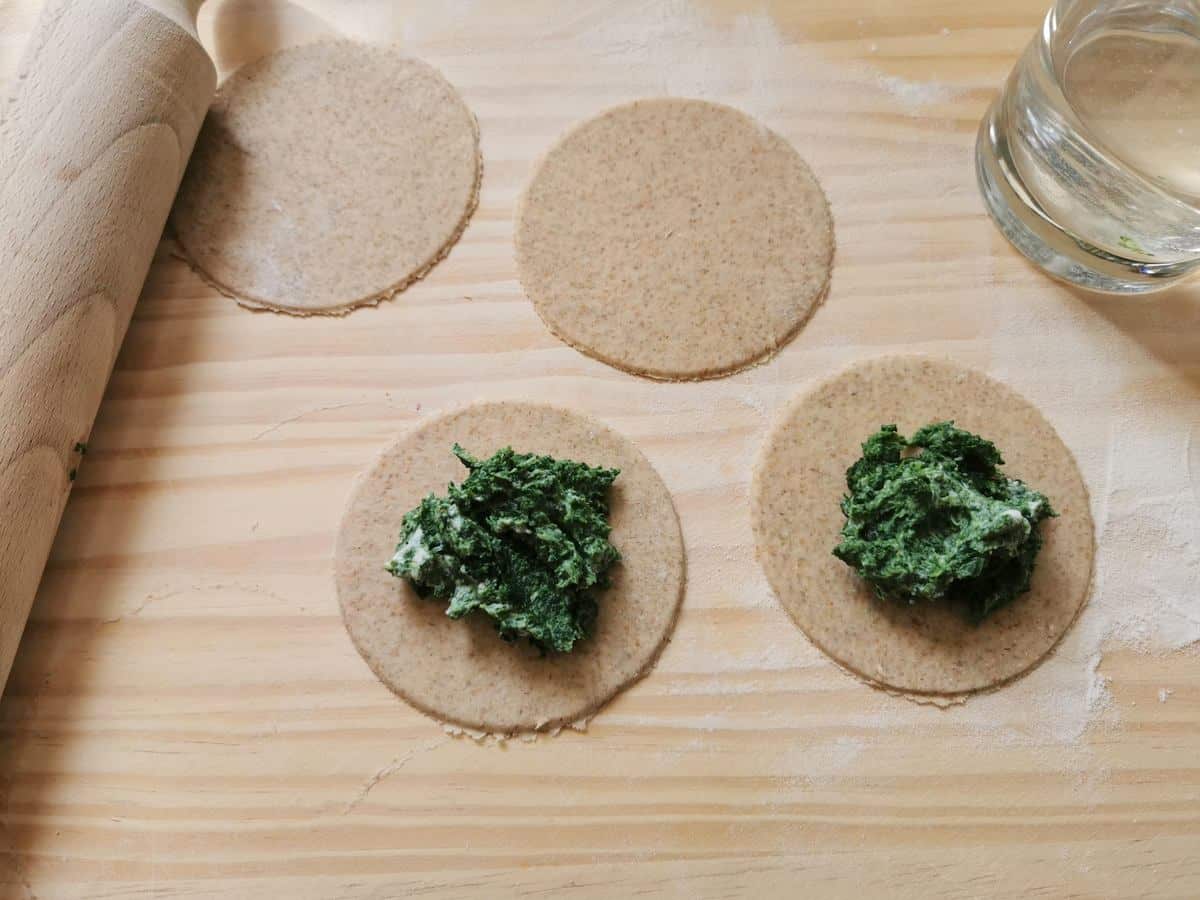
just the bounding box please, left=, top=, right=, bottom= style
left=516, top=98, right=834, bottom=380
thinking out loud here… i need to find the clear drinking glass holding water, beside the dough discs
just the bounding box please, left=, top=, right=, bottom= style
left=976, top=0, right=1200, bottom=294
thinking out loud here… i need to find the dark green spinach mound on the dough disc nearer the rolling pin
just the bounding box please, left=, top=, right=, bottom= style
left=388, top=444, right=620, bottom=653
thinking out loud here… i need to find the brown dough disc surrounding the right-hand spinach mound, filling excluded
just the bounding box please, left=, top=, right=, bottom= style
left=751, top=356, right=1093, bottom=695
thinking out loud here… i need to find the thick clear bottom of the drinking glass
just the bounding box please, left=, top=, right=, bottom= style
left=976, top=101, right=1194, bottom=294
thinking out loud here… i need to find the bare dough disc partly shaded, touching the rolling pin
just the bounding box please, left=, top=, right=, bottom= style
left=172, top=41, right=481, bottom=316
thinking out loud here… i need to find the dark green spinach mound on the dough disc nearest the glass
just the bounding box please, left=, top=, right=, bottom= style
left=833, top=422, right=1057, bottom=622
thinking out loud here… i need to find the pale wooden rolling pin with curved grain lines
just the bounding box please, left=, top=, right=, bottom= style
left=0, top=0, right=216, bottom=686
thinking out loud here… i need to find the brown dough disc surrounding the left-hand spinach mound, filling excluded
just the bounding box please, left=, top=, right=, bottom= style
left=335, top=402, right=684, bottom=734
